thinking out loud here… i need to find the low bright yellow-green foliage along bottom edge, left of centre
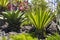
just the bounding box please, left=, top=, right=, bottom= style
left=10, top=33, right=38, bottom=40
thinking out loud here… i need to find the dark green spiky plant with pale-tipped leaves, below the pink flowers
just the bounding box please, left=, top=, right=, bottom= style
left=3, top=10, right=26, bottom=30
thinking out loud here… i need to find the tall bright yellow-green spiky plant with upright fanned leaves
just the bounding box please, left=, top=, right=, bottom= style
left=27, top=7, right=55, bottom=37
